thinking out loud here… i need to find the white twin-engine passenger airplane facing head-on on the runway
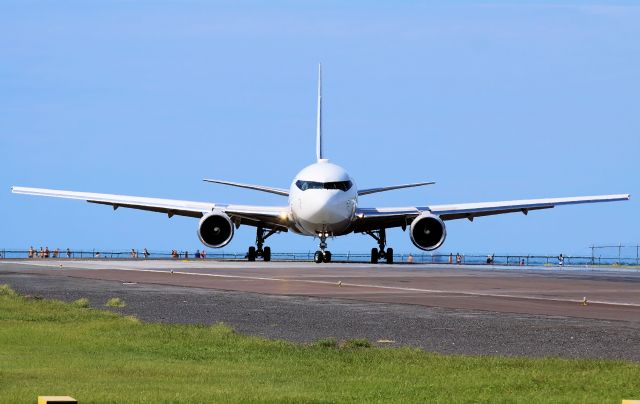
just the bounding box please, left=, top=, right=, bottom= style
left=12, top=65, right=630, bottom=264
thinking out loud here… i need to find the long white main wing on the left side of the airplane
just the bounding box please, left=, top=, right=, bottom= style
left=11, top=187, right=288, bottom=231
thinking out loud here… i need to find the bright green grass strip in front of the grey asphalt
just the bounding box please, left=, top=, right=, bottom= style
left=0, top=287, right=640, bottom=403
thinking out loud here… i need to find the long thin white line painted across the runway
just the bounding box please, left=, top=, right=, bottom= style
left=5, top=262, right=640, bottom=307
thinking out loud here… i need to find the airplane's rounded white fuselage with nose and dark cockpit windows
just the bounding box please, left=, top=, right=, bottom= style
left=289, top=160, right=358, bottom=236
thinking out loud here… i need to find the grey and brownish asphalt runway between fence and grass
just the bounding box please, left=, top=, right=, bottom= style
left=0, top=259, right=640, bottom=361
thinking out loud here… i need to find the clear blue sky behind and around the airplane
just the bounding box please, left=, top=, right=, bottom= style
left=0, top=0, right=640, bottom=254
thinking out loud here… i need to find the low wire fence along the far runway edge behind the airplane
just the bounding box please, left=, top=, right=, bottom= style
left=0, top=249, right=640, bottom=266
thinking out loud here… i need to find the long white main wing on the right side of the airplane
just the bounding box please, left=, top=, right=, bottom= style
left=355, top=194, right=630, bottom=232
